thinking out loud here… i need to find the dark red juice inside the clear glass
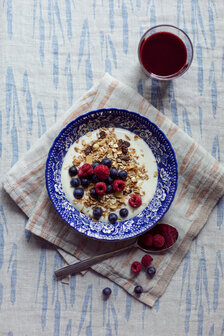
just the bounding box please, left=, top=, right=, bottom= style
left=140, top=32, right=187, bottom=76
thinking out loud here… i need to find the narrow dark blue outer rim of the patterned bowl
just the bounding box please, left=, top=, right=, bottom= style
left=45, top=107, right=179, bottom=242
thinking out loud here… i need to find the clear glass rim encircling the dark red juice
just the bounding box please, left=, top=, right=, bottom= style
left=138, top=24, right=194, bottom=80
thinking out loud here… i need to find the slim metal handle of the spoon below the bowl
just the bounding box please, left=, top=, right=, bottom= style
left=54, top=244, right=133, bottom=279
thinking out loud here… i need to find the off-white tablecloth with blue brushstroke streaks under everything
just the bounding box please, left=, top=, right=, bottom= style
left=0, top=0, right=224, bottom=336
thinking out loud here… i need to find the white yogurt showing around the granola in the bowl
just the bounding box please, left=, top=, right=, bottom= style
left=61, top=128, right=158, bottom=222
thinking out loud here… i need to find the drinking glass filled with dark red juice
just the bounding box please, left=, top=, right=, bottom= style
left=138, top=25, right=193, bottom=80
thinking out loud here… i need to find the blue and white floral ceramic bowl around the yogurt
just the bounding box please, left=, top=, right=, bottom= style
left=45, top=108, right=178, bottom=241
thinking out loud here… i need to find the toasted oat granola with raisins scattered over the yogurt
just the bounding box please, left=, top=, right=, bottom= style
left=73, top=128, right=149, bottom=217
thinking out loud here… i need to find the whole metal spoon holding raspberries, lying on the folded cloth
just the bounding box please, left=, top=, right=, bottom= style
left=55, top=224, right=179, bottom=280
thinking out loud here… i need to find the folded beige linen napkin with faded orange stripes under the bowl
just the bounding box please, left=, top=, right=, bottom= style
left=4, top=74, right=224, bottom=307
